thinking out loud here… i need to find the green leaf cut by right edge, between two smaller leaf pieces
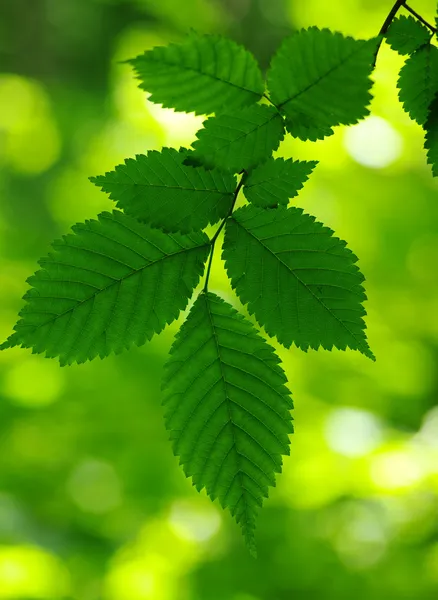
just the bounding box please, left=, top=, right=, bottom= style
left=397, top=44, right=438, bottom=125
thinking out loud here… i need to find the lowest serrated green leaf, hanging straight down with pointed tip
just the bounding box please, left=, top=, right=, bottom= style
left=163, top=293, right=293, bottom=553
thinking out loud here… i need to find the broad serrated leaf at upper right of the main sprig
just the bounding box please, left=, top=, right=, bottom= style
left=268, top=27, right=377, bottom=140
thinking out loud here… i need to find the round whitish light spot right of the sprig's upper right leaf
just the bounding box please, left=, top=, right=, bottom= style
left=344, top=116, right=403, bottom=169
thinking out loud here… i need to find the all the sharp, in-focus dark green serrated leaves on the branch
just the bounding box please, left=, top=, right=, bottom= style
left=1, top=0, right=438, bottom=553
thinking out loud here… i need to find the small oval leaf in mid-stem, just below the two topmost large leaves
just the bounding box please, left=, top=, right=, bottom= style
left=192, top=104, right=284, bottom=173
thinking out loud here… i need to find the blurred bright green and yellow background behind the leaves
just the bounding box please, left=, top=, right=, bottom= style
left=0, top=0, right=438, bottom=600
